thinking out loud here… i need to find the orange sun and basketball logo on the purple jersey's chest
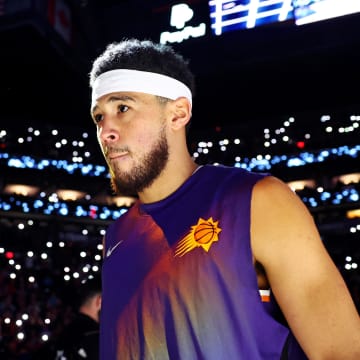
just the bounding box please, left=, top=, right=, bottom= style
left=175, top=217, right=221, bottom=257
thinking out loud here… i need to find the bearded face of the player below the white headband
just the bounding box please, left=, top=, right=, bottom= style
left=93, top=92, right=169, bottom=195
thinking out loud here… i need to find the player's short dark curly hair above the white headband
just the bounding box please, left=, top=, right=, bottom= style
left=90, top=38, right=195, bottom=96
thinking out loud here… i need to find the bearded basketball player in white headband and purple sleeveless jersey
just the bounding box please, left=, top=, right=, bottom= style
left=90, top=39, right=360, bottom=360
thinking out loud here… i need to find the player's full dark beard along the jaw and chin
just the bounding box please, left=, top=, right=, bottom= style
left=110, top=128, right=169, bottom=196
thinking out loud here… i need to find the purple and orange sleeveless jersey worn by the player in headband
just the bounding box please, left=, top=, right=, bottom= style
left=100, top=165, right=306, bottom=360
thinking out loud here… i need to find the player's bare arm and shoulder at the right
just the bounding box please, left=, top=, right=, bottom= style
left=251, top=177, right=360, bottom=359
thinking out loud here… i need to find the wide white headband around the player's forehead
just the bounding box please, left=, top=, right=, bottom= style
left=91, top=69, right=192, bottom=108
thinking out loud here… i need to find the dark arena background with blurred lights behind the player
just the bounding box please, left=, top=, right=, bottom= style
left=0, top=0, right=360, bottom=359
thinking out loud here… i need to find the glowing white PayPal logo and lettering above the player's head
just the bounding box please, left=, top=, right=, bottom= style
left=160, top=3, right=206, bottom=44
